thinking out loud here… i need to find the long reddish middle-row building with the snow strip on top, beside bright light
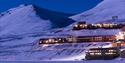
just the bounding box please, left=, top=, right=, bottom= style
left=70, top=29, right=124, bottom=43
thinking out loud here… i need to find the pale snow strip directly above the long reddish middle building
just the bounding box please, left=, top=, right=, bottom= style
left=67, top=29, right=121, bottom=36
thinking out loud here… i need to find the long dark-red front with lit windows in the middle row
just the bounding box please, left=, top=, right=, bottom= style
left=40, top=36, right=113, bottom=43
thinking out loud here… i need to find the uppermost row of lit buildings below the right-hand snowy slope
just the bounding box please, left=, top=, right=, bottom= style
left=72, top=22, right=125, bottom=30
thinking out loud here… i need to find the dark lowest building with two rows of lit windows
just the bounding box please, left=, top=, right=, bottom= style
left=85, top=48, right=120, bottom=60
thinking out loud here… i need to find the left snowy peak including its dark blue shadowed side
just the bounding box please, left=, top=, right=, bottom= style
left=0, top=5, right=73, bottom=36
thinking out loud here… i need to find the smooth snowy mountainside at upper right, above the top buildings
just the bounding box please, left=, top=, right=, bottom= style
left=70, top=0, right=125, bottom=23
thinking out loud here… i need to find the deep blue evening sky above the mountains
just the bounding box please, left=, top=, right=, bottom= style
left=0, top=0, right=102, bottom=13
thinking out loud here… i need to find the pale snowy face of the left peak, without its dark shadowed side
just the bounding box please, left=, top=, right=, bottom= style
left=0, top=5, right=52, bottom=36
